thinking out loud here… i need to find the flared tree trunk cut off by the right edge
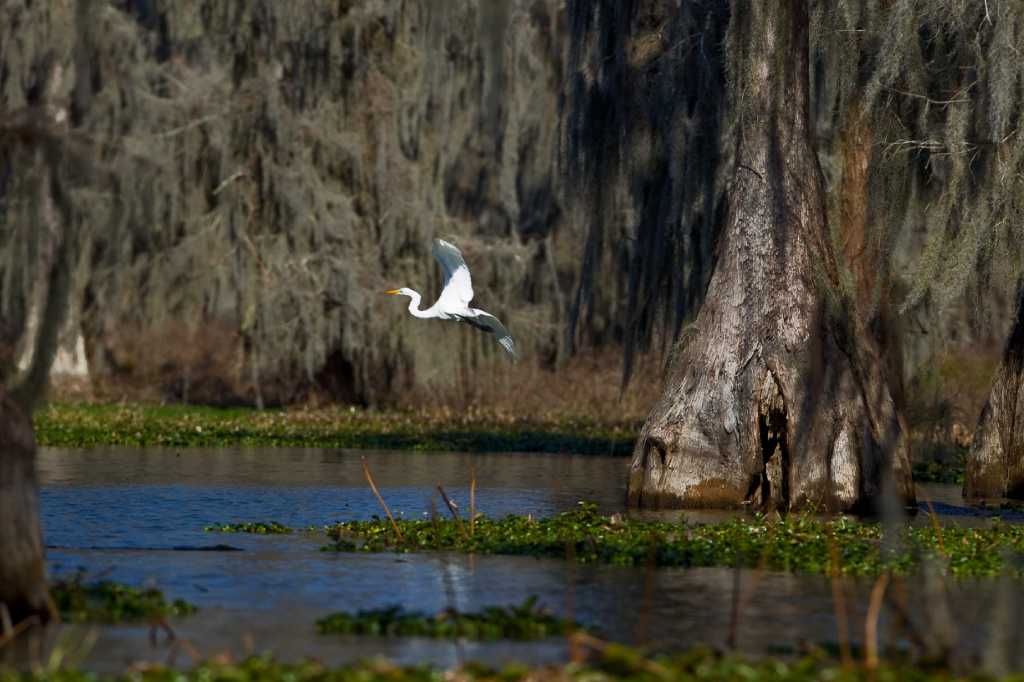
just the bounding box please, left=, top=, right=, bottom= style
left=964, top=283, right=1024, bottom=499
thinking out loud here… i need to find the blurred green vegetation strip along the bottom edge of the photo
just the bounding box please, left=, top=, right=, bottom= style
left=0, top=644, right=1007, bottom=682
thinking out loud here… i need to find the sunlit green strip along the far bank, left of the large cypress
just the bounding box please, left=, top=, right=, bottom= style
left=35, top=403, right=640, bottom=455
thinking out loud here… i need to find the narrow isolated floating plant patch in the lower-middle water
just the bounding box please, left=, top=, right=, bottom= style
left=316, top=596, right=585, bottom=640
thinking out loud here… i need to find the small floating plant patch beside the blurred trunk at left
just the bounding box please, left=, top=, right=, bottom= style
left=50, top=576, right=196, bottom=623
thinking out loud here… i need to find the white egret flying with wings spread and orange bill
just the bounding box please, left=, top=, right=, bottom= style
left=384, top=240, right=518, bottom=357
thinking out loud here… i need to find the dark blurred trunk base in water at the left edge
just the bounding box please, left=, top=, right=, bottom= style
left=0, top=388, right=50, bottom=623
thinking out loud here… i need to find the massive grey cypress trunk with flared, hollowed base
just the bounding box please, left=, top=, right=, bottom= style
left=629, top=0, right=913, bottom=510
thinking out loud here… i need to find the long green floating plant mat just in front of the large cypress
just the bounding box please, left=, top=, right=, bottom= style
left=324, top=503, right=1024, bottom=578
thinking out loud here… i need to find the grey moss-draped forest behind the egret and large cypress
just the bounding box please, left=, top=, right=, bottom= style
left=0, top=0, right=1024, bottom=471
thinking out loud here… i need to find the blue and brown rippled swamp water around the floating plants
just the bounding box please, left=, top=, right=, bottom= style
left=14, top=449, right=1022, bottom=671
